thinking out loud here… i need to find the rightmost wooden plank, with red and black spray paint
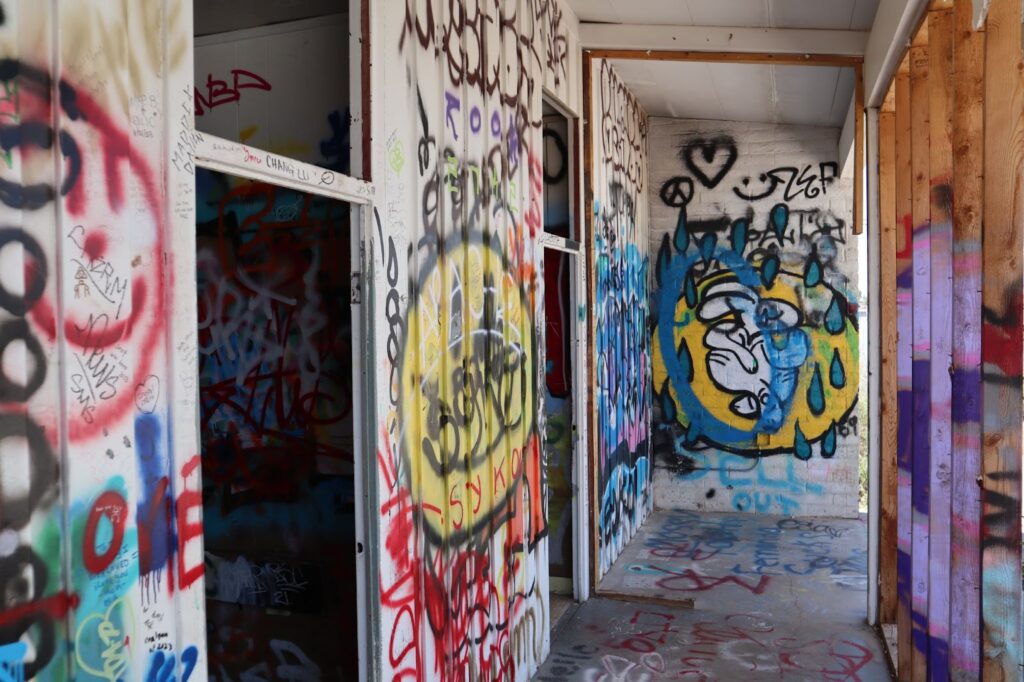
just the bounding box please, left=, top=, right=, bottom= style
left=981, top=0, right=1024, bottom=682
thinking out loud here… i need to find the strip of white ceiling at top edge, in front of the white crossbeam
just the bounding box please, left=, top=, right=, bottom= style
left=569, top=0, right=879, bottom=31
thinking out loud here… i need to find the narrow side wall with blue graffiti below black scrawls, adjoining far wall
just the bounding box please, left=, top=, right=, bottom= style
left=590, top=59, right=652, bottom=573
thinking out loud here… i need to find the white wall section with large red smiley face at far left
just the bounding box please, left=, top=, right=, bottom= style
left=0, top=0, right=206, bottom=681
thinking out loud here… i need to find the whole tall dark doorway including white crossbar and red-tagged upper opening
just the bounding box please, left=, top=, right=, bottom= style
left=195, top=0, right=373, bottom=681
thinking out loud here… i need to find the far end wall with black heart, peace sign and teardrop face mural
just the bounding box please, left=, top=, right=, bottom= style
left=648, top=119, right=860, bottom=515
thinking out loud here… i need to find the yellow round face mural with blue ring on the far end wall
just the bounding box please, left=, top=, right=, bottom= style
left=652, top=271, right=859, bottom=459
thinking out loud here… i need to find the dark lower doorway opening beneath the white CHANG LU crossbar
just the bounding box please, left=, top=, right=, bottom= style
left=197, top=169, right=359, bottom=680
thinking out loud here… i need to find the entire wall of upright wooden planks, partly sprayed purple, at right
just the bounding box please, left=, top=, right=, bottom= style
left=877, top=0, right=1024, bottom=681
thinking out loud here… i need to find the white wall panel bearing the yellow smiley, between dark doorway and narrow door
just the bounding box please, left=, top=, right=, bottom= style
left=368, top=0, right=580, bottom=680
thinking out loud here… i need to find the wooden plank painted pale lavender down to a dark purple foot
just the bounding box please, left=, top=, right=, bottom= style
left=926, top=2, right=953, bottom=680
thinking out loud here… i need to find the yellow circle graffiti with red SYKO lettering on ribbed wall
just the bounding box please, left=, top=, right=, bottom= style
left=400, top=242, right=539, bottom=542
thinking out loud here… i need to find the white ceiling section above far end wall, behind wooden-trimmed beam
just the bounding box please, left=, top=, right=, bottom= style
left=612, top=59, right=854, bottom=128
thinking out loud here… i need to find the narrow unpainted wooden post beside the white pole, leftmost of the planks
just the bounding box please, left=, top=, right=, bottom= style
left=879, top=87, right=898, bottom=623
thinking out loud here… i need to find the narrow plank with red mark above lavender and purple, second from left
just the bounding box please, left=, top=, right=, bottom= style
left=895, top=55, right=913, bottom=680
